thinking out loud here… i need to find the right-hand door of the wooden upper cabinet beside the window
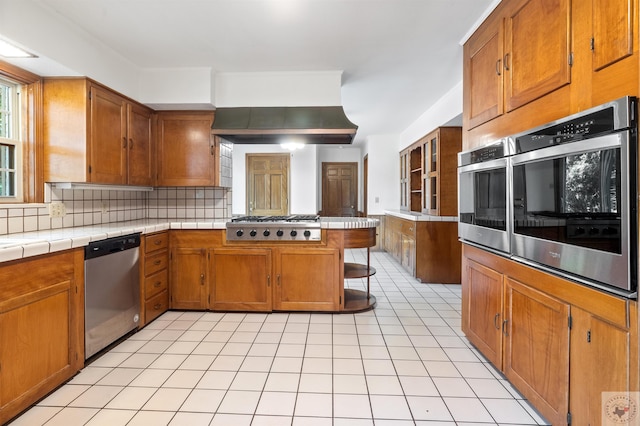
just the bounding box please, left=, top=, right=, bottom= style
left=127, top=104, right=153, bottom=186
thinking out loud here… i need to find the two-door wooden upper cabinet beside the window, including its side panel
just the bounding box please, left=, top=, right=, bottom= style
left=43, top=78, right=153, bottom=186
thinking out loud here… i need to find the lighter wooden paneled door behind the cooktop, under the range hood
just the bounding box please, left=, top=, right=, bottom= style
left=247, top=154, right=289, bottom=216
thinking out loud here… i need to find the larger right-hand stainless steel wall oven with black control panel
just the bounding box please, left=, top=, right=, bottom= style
left=511, top=97, right=638, bottom=297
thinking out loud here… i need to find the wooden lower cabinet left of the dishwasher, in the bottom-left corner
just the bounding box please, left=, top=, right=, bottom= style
left=0, top=249, right=84, bottom=424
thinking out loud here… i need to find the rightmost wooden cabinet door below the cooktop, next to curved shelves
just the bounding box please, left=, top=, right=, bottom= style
left=274, top=247, right=340, bottom=311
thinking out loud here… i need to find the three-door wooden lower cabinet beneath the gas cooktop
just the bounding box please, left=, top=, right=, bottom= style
left=169, top=230, right=344, bottom=312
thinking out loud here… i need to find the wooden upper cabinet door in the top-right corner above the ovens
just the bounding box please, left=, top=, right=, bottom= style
left=592, top=0, right=634, bottom=71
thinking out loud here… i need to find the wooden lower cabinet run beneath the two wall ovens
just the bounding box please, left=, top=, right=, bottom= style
left=462, top=245, right=639, bottom=425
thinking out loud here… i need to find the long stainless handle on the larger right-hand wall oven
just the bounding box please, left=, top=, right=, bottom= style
left=511, top=131, right=628, bottom=166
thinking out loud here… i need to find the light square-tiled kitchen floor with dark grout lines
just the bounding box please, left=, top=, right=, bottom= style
left=12, top=250, right=546, bottom=426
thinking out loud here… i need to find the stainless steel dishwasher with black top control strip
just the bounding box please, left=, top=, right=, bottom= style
left=84, top=233, right=140, bottom=359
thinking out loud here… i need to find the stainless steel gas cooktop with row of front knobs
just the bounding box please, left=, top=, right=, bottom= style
left=226, top=215, right=321, bottom=242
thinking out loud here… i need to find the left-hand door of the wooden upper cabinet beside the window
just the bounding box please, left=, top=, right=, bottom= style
left=89, top=86, right=128, bottom=184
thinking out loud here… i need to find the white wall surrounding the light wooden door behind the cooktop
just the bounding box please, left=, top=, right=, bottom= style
left=232, top=144, right=319, bottom=215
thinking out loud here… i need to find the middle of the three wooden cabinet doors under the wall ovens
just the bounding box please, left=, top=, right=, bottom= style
left=503, top=278, right=569, bottom=425
